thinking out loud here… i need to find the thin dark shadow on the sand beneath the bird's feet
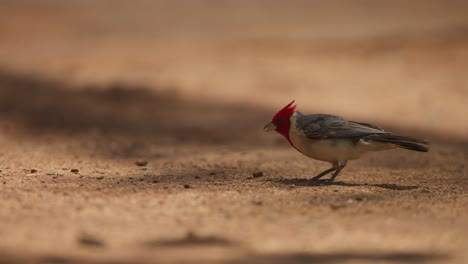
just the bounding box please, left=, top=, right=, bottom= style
left=270, top=178, right=419, bottom=191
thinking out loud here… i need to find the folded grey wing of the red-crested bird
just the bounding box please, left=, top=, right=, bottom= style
left=296, top=112, right=388, bottom=139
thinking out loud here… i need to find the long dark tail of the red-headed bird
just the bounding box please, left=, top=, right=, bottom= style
left=366, top=134, right=429, bottom=152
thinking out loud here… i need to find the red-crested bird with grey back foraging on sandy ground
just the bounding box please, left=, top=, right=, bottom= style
left=264, top=100, right=429, bottom=184
